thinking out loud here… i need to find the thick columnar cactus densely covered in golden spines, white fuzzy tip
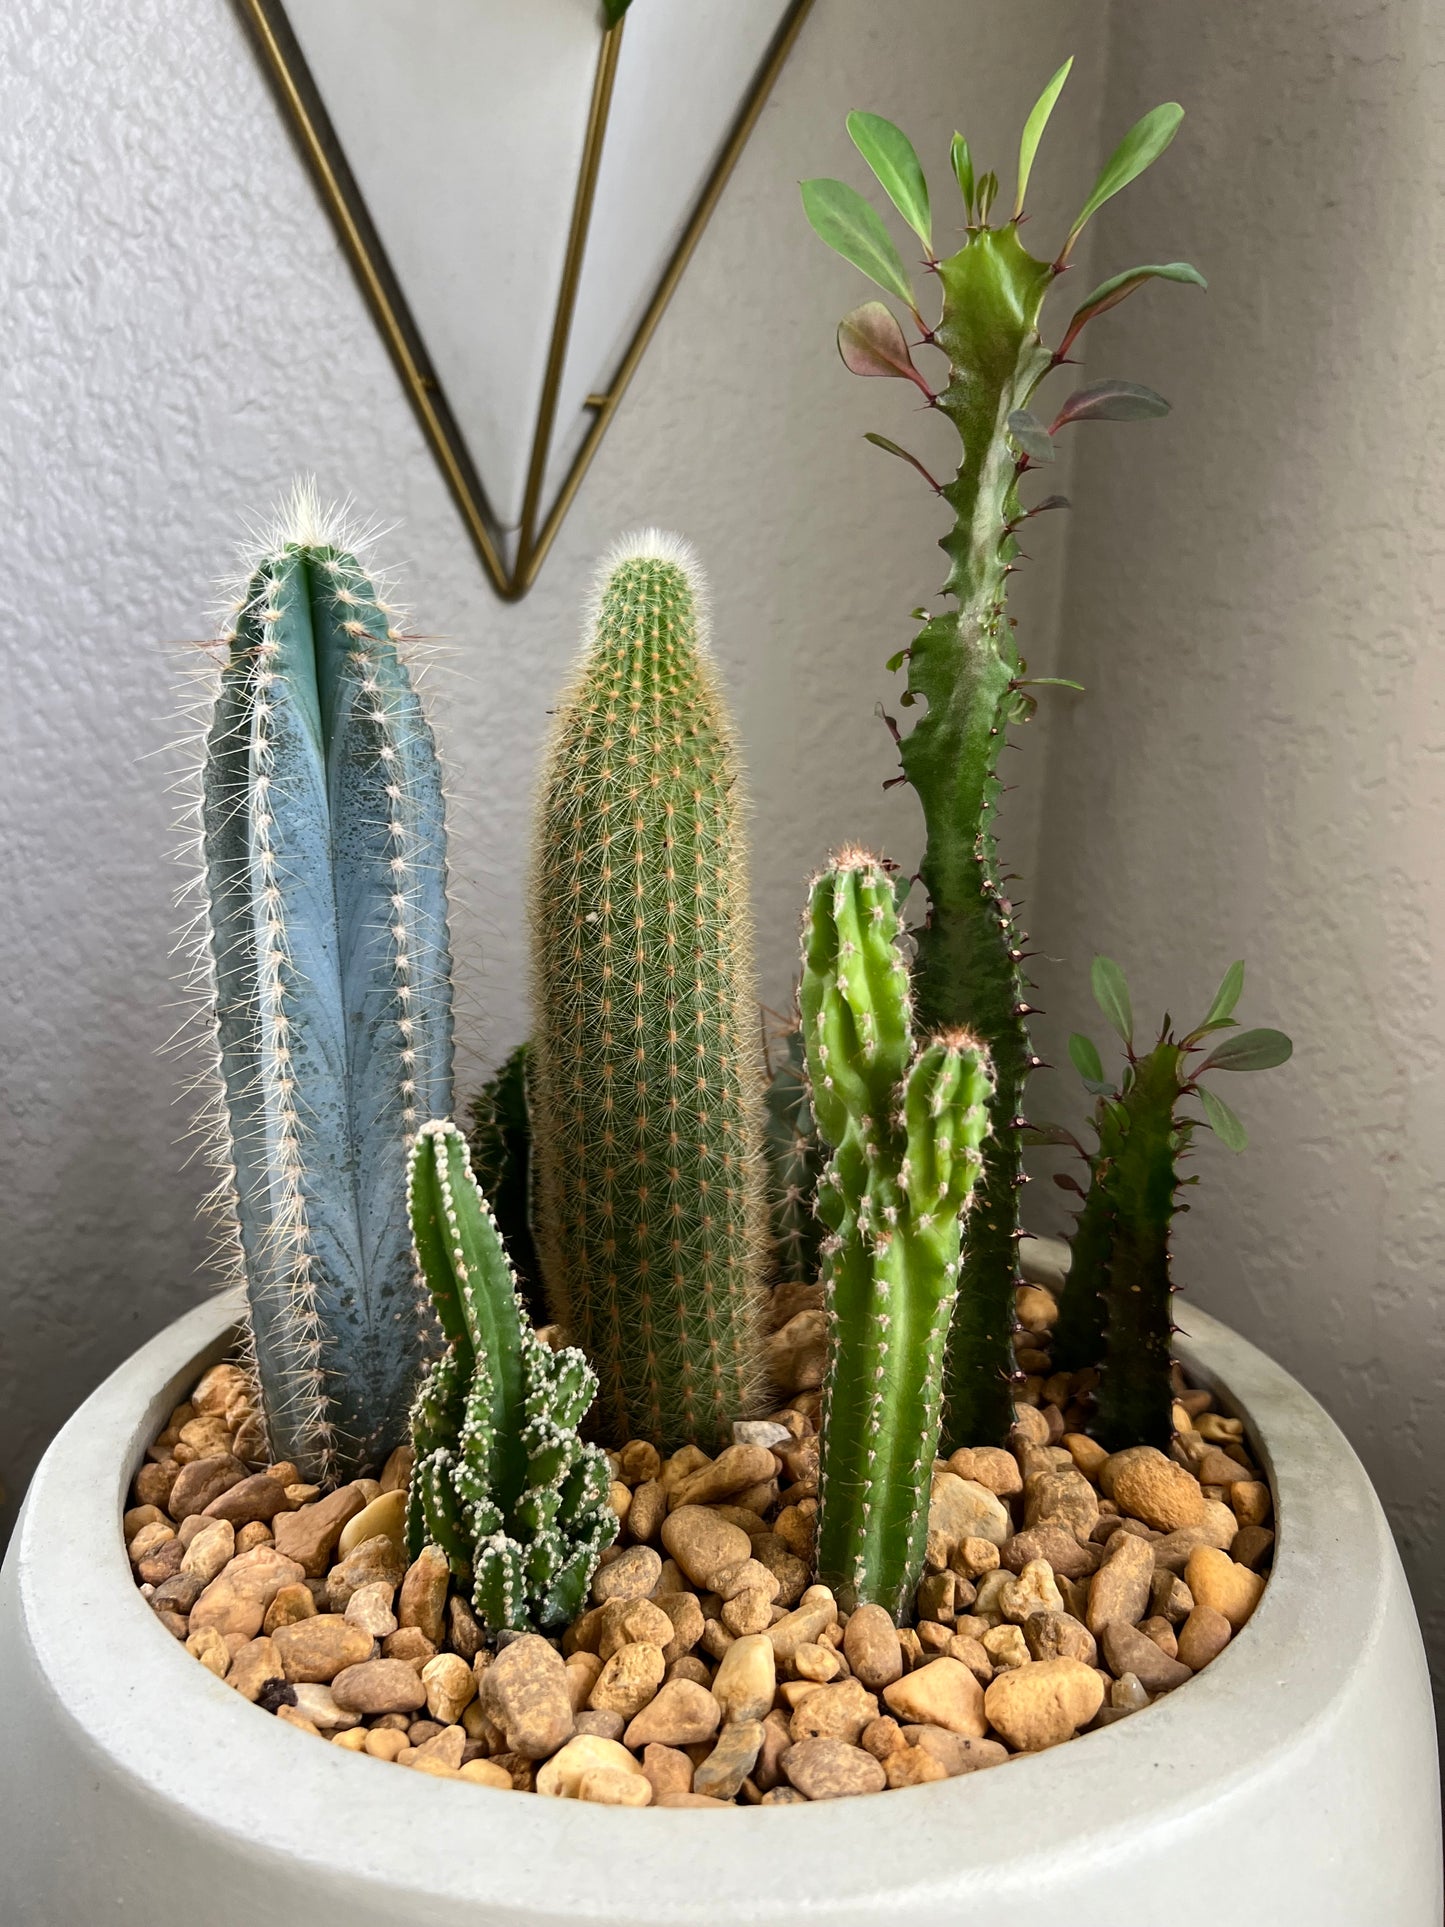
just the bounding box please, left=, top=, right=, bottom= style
left=532, top=532, right=767, bottom=1449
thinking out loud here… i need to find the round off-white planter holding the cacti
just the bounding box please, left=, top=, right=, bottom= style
left=0, top=1305, right=1441, bottom=1927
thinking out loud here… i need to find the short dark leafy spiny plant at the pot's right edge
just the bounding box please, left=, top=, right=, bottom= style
left=1054, top=958, right=1293, bottom=1451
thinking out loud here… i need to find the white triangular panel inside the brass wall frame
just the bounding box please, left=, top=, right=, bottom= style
left=285, top=0, right=788, bottom=558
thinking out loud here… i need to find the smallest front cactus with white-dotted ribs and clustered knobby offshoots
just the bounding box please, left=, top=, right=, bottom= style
left=407, top=1122, right=617, bottom=1632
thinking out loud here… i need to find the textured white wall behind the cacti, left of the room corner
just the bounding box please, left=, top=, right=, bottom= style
left=0, top=0, right=1106, bottom=1533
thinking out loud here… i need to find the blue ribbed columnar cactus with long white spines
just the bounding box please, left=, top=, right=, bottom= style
left=200, top=488, right=451, bottom=1480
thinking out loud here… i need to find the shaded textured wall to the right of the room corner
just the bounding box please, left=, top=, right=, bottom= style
left=1037, top=0, right=1445, bottom=1703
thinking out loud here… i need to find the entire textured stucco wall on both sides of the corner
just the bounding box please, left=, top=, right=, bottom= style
left=0, top=0, right=1445, bottom=1718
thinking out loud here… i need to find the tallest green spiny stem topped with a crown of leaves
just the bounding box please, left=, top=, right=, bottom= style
left=803, top=75, right=1202, bottom=1445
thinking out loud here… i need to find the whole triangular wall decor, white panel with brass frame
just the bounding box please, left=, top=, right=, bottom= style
left=239, top=0, right=811, bottom=599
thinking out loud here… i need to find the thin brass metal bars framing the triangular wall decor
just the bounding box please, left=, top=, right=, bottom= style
left=241, top=0, right=813, bottom=601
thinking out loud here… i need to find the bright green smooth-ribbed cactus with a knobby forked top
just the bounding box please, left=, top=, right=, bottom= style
left=800, top=850, right=990, bottom=1617
